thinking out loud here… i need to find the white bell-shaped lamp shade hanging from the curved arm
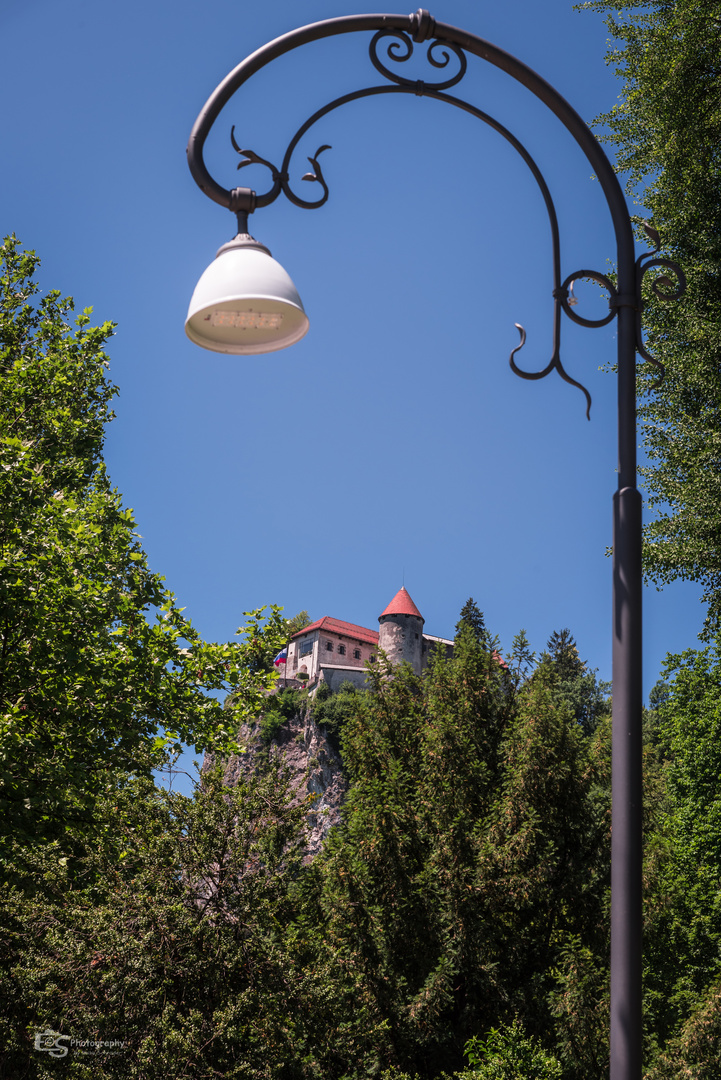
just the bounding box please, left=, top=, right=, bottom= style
left=186, top=235, right=309, bottom=353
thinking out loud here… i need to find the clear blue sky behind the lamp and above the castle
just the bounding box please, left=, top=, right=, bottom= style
left=0, top=0, right=703, bottom=786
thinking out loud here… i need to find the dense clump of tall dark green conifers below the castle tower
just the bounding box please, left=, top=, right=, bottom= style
left=319, top=632, right=608, bottom=1077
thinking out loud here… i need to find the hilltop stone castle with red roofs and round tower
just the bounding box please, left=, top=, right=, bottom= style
left=282, top=585, right=453, bottom=691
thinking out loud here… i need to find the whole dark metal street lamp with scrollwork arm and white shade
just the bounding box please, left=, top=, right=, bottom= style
left=186, top=10, right=685, bottom=1080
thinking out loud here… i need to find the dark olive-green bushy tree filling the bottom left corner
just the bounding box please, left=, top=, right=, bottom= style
left=0, top=769, right=376, bottom=1080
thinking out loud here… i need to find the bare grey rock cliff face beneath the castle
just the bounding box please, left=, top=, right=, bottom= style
left=203, top=710, right=348, bottom=861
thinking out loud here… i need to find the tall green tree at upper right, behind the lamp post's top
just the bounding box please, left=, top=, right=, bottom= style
left=582, top=0, right=721, bottom=635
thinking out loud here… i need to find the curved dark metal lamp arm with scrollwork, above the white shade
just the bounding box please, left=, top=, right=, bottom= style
left=188, top=9, right=637, bottom=447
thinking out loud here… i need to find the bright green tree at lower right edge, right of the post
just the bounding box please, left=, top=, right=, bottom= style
left=644, top=642, right=721, bottom=1047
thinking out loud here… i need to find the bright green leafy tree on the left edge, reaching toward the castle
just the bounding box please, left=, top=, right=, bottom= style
left=0, top=238, right=283, bottom=873
